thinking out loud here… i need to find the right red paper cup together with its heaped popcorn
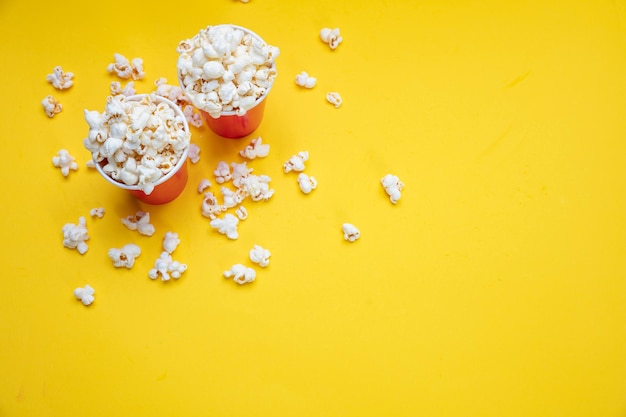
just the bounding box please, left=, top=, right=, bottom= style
left=176, top=25, right=280, bottom=138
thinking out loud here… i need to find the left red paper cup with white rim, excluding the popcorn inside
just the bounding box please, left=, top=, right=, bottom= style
left=95, top=94, right=189, bottom=204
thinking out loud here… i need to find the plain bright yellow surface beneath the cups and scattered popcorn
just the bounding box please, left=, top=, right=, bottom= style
left=0, top=0, right=626, bottom=417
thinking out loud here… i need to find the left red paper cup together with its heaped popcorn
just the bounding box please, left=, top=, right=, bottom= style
left=83, top=93, right=191, bottom=204
